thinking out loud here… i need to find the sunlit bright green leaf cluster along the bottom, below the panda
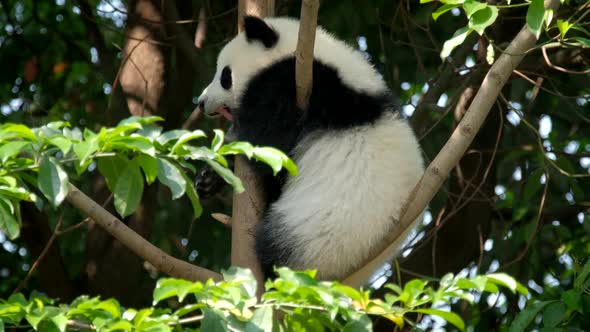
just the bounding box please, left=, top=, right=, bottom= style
left=0, top=268, right=526, bottom=331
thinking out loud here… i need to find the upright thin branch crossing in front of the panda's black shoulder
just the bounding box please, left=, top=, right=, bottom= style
left=295, top=0, right=320, bottom=111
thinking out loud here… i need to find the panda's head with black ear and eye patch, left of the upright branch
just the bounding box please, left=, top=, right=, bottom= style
left=198, top=16, right=298, bottom=120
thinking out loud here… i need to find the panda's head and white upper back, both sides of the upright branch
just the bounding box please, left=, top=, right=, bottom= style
left=198, top=16, right=387, bottom=120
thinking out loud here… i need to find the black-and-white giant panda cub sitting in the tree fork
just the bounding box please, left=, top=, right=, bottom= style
left=198, top=16, right=423, bottom=280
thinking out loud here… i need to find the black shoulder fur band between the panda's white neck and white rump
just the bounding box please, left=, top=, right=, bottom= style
left=235, top=57, right=397, bottom=153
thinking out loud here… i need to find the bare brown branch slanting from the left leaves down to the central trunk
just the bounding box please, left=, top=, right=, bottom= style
left=66, top=184, right=222, bottom=281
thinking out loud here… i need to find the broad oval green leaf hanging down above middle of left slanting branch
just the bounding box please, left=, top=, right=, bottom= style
left=113, top=160, right=143, bottom=218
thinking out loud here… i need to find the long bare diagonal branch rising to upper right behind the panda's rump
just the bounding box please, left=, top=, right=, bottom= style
left=343, top=0, right=559, bottom=287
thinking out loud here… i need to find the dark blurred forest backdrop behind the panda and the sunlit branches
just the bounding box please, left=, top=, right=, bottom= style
left=0, top=0, right=590, bottom=331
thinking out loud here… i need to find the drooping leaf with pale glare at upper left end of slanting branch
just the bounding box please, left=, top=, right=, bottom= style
left=37, top=154, right=69, bottom=207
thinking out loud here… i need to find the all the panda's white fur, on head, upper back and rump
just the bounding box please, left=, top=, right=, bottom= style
left=199, top=18, right=423, bottom=279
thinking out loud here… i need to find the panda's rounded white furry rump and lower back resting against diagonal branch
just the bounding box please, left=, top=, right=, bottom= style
left=264, top=112, right=423, bottom=278
